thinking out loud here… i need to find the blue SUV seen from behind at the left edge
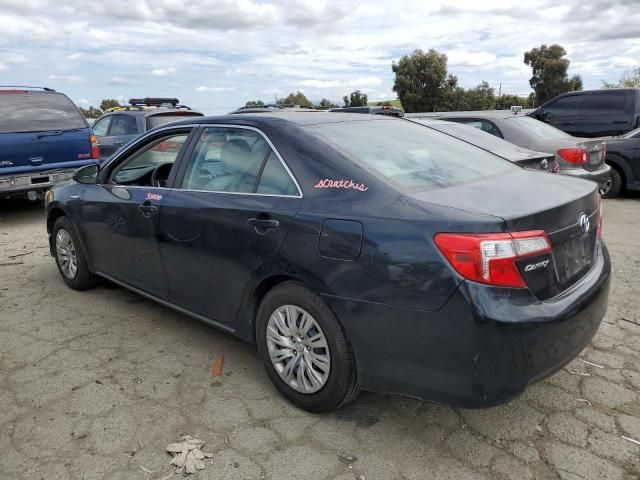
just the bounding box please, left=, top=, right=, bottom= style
left=0, top=86, right=98, bottom=200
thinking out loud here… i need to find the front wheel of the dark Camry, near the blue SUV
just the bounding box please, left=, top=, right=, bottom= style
left=53, top=217, right=98, bottom=290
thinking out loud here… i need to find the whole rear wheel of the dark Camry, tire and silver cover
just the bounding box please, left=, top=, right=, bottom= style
left=256, top=282, right=358, bottom=412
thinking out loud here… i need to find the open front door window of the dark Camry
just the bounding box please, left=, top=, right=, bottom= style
left=108, top=132, right=189, bottom=186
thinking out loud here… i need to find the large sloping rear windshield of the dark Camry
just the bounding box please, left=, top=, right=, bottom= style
left=305, top=119, right=519, bottom=190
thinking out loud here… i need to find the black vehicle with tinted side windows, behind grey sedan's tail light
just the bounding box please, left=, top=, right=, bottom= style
left=529, top=88, right=640, bottom=137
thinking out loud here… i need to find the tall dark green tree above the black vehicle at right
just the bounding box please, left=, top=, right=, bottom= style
left=524, top=44, right=582, bottom=105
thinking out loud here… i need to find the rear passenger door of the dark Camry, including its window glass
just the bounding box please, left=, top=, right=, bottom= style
left=160, top=125, right=301, bottom=322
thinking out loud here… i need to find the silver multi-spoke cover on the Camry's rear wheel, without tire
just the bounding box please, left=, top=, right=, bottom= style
left=266, top=305, right=331, bottom=394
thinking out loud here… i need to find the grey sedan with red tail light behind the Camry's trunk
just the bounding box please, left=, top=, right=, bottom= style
left=407, top=110, right=611, bottom=189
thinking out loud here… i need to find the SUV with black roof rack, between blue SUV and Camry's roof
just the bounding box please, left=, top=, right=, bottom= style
left=92, top=98, right=202, bottom=161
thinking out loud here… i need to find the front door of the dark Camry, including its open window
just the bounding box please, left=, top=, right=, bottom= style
left=80, top=127, right=191, bottom=299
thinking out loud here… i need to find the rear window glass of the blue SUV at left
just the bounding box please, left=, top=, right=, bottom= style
left=0, top=92, right=87, bottom=133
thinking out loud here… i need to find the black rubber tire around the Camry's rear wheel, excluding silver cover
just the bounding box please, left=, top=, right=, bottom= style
left=256, top=281, right=358, bottom=412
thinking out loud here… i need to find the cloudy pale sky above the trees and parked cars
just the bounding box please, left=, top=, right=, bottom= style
left=0, top=0, right=640, bottom=114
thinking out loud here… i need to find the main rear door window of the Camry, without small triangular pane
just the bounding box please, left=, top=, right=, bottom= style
left=182, top=127, right=271, bottom=193
